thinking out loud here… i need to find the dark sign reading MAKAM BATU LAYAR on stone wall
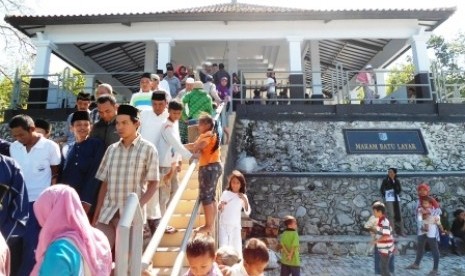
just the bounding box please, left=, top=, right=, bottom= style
left=343, top=129, right=428, bottom=154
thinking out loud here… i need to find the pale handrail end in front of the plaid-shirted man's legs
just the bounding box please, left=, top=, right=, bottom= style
left=115, top=193, right=144, bottom=276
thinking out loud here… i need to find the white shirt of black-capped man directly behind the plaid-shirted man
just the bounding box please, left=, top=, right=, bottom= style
left=139, top=109, right=168, bottom=147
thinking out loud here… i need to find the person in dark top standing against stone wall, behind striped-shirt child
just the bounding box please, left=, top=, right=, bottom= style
left=380, top=168, right=405, bottom=236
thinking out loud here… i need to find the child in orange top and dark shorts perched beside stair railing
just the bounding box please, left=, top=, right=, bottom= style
left=186, top=113, right=223, bottom=234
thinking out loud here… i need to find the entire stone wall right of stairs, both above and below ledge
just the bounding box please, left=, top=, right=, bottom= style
left=234, top=119, right=465, bottom=235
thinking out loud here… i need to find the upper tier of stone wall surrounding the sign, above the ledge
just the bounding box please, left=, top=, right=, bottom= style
left=235, top=119, right=465, bottom=172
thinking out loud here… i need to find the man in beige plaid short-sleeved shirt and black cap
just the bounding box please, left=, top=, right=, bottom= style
left=92, top=105, right=159, bottom=250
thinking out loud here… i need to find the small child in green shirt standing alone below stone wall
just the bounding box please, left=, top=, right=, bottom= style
left=279, top=216, right=300, bottom=276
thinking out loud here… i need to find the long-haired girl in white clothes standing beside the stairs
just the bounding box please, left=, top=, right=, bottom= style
left=218, top=170, right=251, bottom=258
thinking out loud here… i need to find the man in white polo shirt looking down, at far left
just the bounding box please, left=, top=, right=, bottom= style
left=9, top=115, right=61, bottom=275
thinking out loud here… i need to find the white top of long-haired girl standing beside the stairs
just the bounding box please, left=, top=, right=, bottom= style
left=220, top=190, right=250, bottom=227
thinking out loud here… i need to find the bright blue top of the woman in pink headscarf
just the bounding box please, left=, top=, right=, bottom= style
left=39, top=239, right=82, bottom=276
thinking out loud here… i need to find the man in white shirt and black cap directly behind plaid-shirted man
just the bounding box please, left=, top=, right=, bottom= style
left=139, top=91, right=168, bottom=235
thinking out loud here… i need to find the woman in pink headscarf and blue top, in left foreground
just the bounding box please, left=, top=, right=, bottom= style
left=31, top=184, right=112, bottom=276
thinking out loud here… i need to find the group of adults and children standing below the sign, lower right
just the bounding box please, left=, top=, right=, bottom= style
left=364, top=168, right=465, bottom=276
